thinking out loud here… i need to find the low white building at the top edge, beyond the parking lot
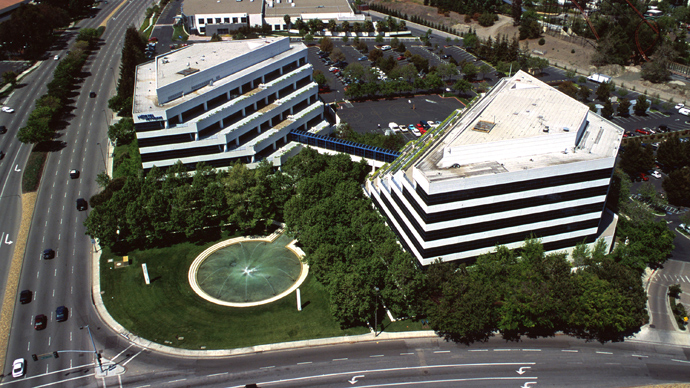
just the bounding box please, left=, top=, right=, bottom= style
left=180, top=0, right=364, bottom=35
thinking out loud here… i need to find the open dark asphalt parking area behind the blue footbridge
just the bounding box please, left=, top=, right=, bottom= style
left=338, top=95, right=464, bottom=141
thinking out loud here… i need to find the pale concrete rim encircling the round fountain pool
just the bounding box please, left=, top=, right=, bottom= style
left=187, top=229, right=309, bottom=307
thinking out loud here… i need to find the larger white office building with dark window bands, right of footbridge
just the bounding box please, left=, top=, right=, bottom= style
left=366, top=71, right=623, bottom=265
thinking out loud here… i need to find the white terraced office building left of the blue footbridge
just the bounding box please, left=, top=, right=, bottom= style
left=133, top=38, right=329, bottom=171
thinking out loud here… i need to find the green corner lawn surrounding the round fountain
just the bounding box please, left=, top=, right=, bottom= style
left=101, top=236, right=368, bottom=349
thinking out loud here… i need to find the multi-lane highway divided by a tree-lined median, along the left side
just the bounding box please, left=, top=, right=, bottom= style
left=0, top=0, right=151, bottom=386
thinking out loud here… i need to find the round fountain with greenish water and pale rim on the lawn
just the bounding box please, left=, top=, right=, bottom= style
left=188, top=233, right=307, bottom=307
